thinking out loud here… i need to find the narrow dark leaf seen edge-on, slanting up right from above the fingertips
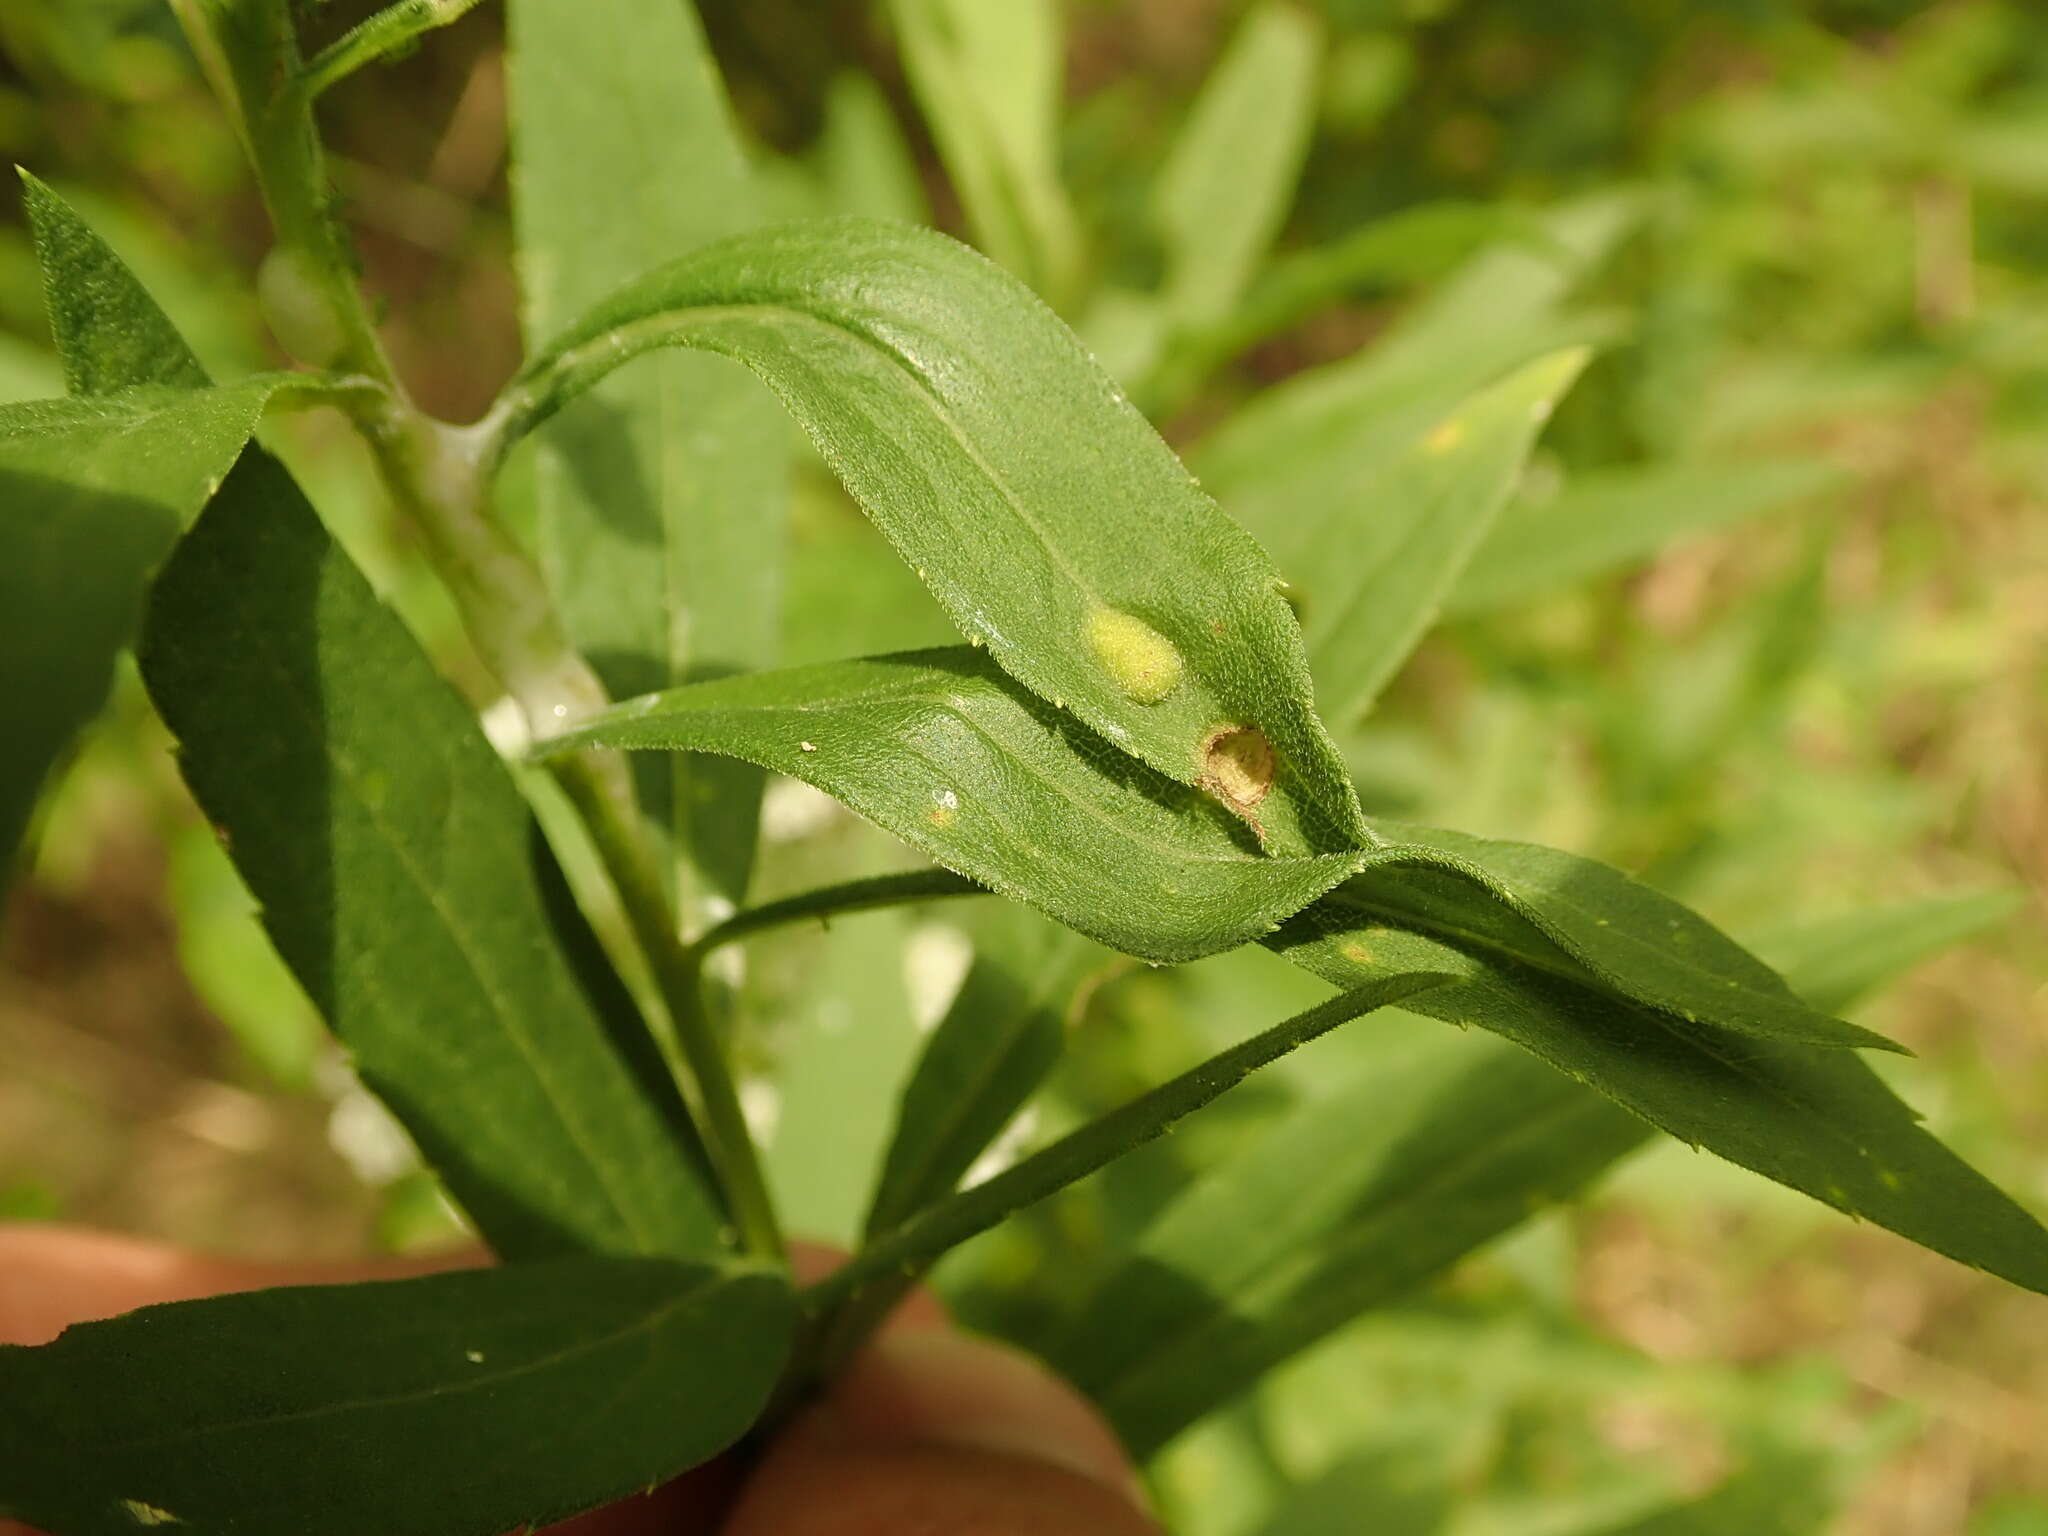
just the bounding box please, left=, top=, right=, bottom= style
left=805, top=973, right=1444, bottom=1313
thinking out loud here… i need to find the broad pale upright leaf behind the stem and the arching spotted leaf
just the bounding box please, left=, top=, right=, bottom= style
left=508, top=0, right=791, bottom=926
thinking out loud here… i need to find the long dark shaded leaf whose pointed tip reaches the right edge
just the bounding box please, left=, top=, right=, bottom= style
left=1268, top=874, right=2048, bottom=1292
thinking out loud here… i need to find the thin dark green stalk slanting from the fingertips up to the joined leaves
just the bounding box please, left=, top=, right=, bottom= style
left=793, top=971, right=1452, bottom=1393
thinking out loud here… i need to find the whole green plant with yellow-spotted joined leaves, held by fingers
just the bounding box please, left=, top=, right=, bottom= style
left=0, top=0, right=2048, bottom=1532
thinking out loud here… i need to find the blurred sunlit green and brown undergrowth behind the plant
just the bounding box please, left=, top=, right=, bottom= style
left=0, top=0, right=2048, bottom=1536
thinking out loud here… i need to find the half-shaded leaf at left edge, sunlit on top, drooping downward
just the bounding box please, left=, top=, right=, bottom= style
left=0, top=375, right=285, bottom=862
